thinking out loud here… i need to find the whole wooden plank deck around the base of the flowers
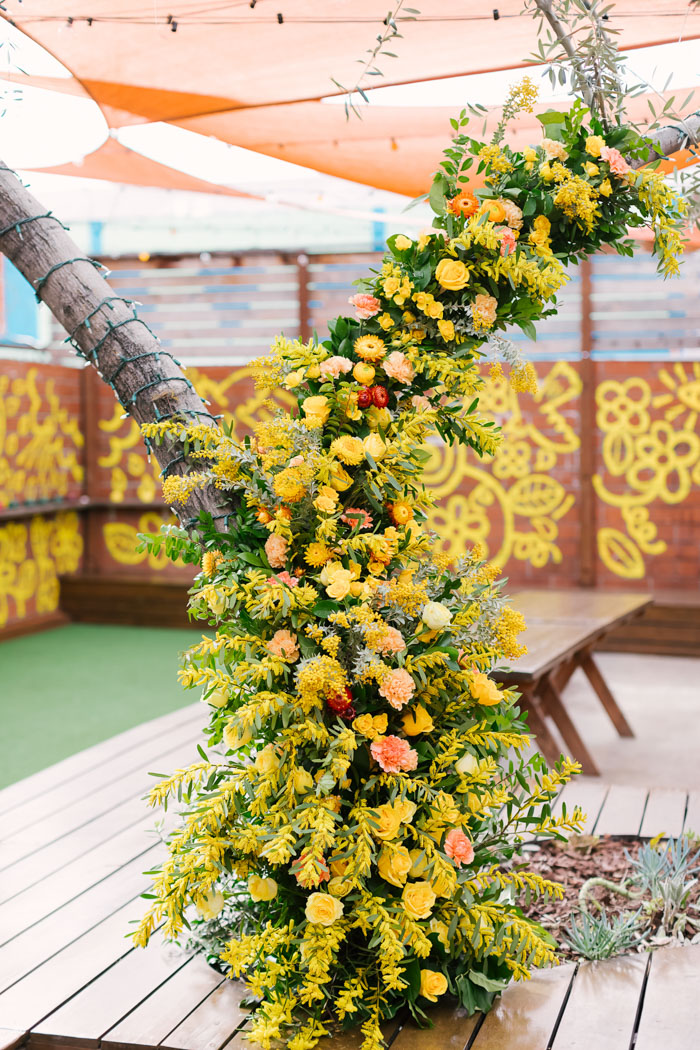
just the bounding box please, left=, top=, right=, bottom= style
left=0, top=705, right=700, bottom=1050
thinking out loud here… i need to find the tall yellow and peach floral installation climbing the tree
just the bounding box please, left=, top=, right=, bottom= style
left=134, top=88, right=682, bottom=1050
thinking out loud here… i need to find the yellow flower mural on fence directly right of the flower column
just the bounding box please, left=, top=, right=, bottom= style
left=425, top=361, right=581, bottom=567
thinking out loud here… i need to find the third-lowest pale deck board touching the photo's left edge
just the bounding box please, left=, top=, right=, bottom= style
left=0, top=816, right=156, bottom=948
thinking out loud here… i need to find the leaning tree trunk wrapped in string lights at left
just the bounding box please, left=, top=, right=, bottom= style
left=0, top=162, right=226, bottom=531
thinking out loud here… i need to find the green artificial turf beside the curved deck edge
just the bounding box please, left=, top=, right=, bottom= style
left=0, top=624, right=201, bottom=788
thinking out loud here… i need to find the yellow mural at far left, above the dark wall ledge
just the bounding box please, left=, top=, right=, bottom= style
left=0, top=368, right=83, bottom=507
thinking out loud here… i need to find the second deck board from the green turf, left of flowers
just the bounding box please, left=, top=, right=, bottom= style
left=0, top=709, right=202, bottom=839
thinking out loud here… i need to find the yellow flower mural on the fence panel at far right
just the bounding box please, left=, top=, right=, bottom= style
left=594, top=362, right=700, bottom=580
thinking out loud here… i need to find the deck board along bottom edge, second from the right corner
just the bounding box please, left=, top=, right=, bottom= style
left=552, top=956, right=648, bottom=1050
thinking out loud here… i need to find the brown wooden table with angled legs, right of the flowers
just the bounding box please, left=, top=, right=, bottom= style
left=497, top=590, right=652, bottom=776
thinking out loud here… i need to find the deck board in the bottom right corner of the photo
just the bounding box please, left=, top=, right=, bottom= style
left=635, top=944, right=700, bottom=1050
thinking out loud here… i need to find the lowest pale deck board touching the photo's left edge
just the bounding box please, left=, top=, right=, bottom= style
left=0, top=899, right=143, bottom=1031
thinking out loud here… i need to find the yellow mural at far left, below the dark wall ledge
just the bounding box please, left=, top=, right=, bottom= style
left=0, top=511, right=83, bottom=627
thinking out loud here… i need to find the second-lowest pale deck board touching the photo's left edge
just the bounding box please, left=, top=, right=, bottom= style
left=0, top=848, right=161, bottom=995
